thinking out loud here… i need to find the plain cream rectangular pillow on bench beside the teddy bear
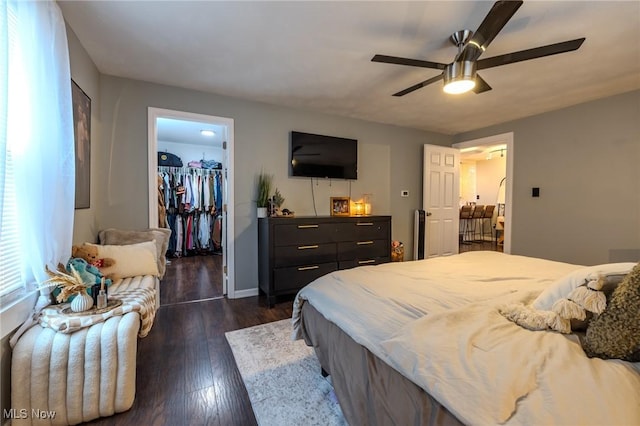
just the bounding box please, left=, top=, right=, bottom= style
left=85, top=241, right=159, bottom=280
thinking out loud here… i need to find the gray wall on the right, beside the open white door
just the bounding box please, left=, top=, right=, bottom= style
left=455, top=91, right=640, bottom=265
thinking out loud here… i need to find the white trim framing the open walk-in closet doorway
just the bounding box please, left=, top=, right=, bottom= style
left=147, top=107, right=236, bottom=299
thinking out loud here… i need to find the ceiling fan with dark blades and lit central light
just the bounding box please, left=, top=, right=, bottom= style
left=371, top=0, right=585, bottom=96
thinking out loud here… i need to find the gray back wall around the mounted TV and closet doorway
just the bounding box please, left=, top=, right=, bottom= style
left=92, top=75, right=452, bottom=290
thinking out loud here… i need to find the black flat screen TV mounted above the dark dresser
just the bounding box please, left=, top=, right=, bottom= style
left=289, top=131, right=358, bottom=180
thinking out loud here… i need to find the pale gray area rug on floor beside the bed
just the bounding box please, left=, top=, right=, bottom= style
left=225, top=319, right=347, bottom=426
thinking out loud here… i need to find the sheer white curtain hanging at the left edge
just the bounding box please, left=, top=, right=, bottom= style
left=5, top=0, right=75, bottom=310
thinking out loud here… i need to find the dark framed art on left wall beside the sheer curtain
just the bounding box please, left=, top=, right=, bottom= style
left=71, top=80, right=91, bottom=209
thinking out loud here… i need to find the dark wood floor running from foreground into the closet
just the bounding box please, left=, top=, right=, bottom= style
left=87, top=256, right=293, bottom=426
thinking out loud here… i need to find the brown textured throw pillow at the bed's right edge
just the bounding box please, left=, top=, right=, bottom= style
left=581, top=263, right=640, bottom=362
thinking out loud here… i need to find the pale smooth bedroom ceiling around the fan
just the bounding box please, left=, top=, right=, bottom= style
left=58, top=0, right=640, bottom=135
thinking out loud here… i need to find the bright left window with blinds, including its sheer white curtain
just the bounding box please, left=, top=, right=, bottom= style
left=0, top=0, right=75, bottom=337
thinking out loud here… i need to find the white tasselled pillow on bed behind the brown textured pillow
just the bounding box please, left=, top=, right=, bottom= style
left=532, top=262, right=635, bottom=311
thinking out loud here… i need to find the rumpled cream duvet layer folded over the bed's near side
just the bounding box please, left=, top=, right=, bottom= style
left=382, top=296, right=640, bottom=425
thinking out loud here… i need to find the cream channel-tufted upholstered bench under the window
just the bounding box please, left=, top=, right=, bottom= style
left=11, top=230, right=170, bottom=425
